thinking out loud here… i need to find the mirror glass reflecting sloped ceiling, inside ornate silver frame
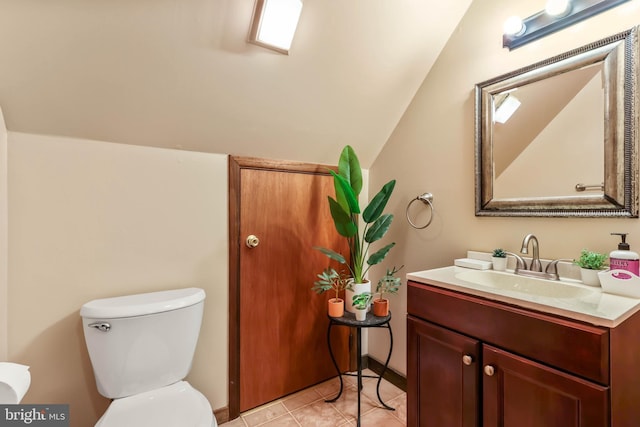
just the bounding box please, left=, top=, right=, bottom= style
left=493, top=62, right=604, bottom=199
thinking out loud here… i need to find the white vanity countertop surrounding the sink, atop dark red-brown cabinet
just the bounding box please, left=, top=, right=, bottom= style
left=407, top=266, right=640, bottom=328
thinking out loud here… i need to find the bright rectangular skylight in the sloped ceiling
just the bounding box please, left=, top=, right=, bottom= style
left=249, top=0, right=302, bottom=54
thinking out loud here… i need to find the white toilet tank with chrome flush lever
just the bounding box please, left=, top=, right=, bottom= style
left=80, top=288, right=205, bottom=399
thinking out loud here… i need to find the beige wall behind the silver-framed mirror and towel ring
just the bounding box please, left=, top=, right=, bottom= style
left=369, top=0, right=640, bottom=372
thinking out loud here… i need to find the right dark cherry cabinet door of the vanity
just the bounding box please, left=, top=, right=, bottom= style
left=482, top=344, right=609, bottom=427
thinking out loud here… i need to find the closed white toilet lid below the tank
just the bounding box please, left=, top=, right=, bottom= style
left=96, top=381, right=216, bottom=427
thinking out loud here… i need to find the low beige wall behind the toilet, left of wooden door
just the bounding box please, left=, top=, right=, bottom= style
left=6, top=132, right=227, bottom=427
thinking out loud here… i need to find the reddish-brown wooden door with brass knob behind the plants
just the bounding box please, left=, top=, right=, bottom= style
left=229, top=158, right=349, bottom=418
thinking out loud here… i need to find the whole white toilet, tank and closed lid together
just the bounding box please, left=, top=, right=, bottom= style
left=80, top=288, right=218, bottom=427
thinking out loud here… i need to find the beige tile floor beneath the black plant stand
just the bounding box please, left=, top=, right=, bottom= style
left=221, top=370, right=407, bottom=427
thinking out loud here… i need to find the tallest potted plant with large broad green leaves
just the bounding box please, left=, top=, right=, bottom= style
left=314, top=145, right=396, bottom=311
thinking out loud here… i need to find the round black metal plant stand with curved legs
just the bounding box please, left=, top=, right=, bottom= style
left=325, top=312, right=395, bottom=426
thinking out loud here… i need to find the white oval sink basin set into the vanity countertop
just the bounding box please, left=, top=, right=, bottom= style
left=455, top=270, right=594, bottom=298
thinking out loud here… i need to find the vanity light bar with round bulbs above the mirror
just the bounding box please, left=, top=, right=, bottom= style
left=502, top=0, right=629, bottom=50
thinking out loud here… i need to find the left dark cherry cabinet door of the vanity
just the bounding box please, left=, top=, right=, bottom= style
left=407, top=316, right=480, bottom=427
